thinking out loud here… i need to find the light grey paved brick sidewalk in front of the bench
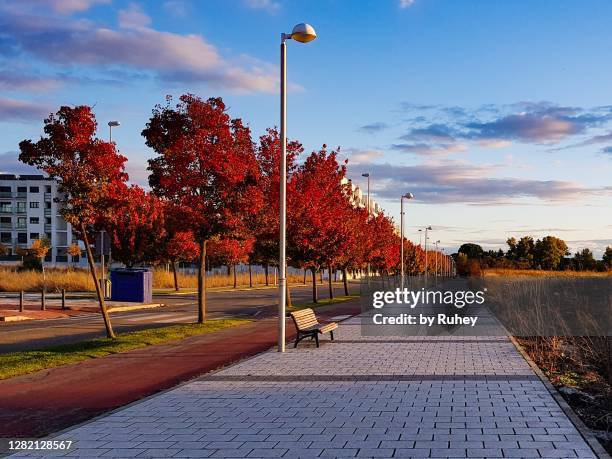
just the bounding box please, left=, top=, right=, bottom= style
left=11, top=318, right=596, bottom=458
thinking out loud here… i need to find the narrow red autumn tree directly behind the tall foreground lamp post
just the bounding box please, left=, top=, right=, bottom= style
left=252, top=129, right=304, bottom=284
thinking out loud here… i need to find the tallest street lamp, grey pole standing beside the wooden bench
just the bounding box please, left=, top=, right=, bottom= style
left=278, top=23, right=317, bottom=352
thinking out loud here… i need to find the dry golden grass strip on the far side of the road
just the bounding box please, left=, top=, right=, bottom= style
left=0, top=267, right=310, bottom=292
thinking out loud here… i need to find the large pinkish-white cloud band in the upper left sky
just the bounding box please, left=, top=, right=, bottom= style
left=0, top=9, right=278, bottom=93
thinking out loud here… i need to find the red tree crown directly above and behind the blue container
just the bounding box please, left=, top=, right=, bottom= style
left=104, top=185, right=166, bottom=267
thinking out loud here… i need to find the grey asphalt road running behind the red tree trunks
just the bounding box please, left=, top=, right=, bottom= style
left=0, top=282, right=359, bottom=353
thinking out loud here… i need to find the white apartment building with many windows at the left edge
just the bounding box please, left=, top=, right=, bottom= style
left=0, top=174, right=86, bottom=265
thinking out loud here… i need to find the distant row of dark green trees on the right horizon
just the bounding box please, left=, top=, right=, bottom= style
left=459, top=236, right=612, bottom=271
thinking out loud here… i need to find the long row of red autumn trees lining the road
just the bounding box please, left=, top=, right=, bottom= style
left=19, top=95, right=440, bottom=337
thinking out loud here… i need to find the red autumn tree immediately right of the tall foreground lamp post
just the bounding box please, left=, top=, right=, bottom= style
left=287, top=145, right=350, bottom=303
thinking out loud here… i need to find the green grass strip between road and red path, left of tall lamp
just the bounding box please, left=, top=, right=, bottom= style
left=0, top=319, right=251, bottom=379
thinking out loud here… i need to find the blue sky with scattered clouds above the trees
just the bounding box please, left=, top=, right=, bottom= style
left=0, top=0, right=612, bottom=257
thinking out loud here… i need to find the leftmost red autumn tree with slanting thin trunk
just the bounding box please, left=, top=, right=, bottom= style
left=19, top=106, right=128, bottom=338
